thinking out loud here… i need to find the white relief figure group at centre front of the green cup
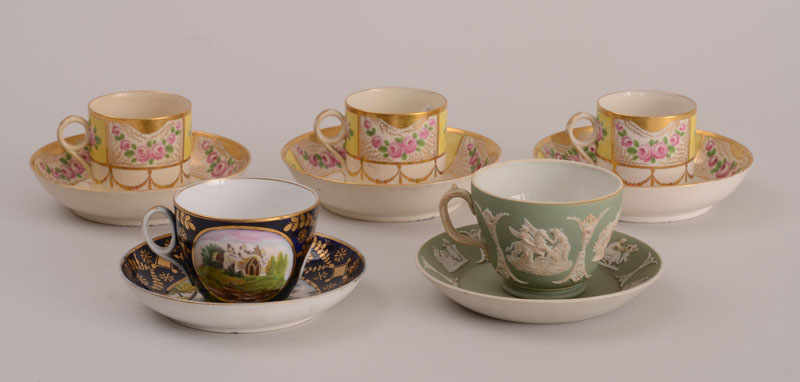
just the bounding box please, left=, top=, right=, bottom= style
left=506, top=218, right=572, bottom=276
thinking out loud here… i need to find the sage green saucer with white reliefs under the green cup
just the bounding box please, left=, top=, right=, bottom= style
left=417, top=224, right=662, bottom=324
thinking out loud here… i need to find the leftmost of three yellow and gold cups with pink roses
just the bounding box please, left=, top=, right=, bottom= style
left=58, top=91, right=192, bottom=191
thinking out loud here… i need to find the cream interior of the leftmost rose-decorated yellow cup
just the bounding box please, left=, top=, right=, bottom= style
left=89, top=91, right=192, bottom=119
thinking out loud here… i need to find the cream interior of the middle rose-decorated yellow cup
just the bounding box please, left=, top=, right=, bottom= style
left=345, top=88, right=447, bottom=114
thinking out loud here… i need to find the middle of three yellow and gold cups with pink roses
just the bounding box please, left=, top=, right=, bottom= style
left=314, top=88, right=447, bottom=184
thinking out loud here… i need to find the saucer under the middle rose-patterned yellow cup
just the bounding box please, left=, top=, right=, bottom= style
left=281, top=126, right=501, bottom=222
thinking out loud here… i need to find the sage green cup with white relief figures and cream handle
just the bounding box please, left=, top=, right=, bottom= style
left=439, top=159, right=623, bottom=299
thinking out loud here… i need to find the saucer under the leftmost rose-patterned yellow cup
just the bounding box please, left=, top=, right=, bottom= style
left=30, top=131, right=250, bottom=226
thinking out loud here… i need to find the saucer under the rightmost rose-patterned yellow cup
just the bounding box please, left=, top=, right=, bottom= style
left=533, top=127, right=753, bottom=223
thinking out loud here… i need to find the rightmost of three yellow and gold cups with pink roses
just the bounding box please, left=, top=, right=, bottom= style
left=567, top=90, right=700, bottom=187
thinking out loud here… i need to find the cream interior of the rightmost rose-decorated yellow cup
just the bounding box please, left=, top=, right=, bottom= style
left=597, top=90, right=697, bottom=117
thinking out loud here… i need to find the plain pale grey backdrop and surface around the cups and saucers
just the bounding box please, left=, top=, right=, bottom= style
left=0, top=1, right=800, bottom=381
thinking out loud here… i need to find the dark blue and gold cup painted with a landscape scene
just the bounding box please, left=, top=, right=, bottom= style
left=142, top=178, right=319, bottom=302
